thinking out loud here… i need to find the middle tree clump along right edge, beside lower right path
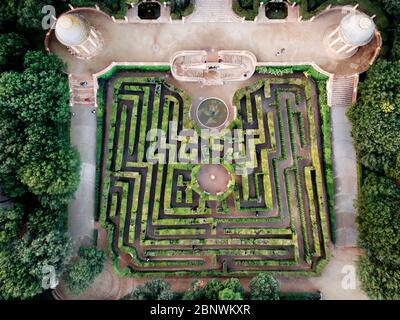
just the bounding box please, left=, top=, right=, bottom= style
left=357, top=173, right=400, bottom=265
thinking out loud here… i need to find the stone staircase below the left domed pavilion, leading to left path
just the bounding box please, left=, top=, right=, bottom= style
left=69, top=76, right=96, bottom=107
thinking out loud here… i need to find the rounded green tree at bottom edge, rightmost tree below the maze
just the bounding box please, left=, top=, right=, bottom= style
left=249, top=273, right=279, bottom=300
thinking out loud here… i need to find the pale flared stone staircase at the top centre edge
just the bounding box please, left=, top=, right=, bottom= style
left=186, top=0, right=241, bottom=23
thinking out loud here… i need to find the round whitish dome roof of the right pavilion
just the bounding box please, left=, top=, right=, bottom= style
left=340, top=13, right=375, bottom=47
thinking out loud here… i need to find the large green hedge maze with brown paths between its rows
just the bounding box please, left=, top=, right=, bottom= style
left=99, top=73, right=329, bottom=275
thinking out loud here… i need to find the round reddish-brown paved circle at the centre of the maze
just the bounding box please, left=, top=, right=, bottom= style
left=197, top=164, right=232, bottom=195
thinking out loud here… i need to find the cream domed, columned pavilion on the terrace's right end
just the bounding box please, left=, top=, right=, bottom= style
left=325, top=12, right=376, bottom=59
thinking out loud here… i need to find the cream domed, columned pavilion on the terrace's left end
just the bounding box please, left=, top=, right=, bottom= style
left=55, top=13, right=103, bottom=59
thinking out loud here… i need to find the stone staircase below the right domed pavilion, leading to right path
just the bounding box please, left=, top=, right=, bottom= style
left=328, top=75, right=358, bottom=107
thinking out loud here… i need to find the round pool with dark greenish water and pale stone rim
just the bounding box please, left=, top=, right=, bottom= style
left=196, top=98, right=229, bottom=129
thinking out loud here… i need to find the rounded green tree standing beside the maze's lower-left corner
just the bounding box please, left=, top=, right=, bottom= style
left=64, top=247, right=106, bottom=295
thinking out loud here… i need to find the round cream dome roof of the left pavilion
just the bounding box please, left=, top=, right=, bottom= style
left=56, top=14, right=90, bottom=46
